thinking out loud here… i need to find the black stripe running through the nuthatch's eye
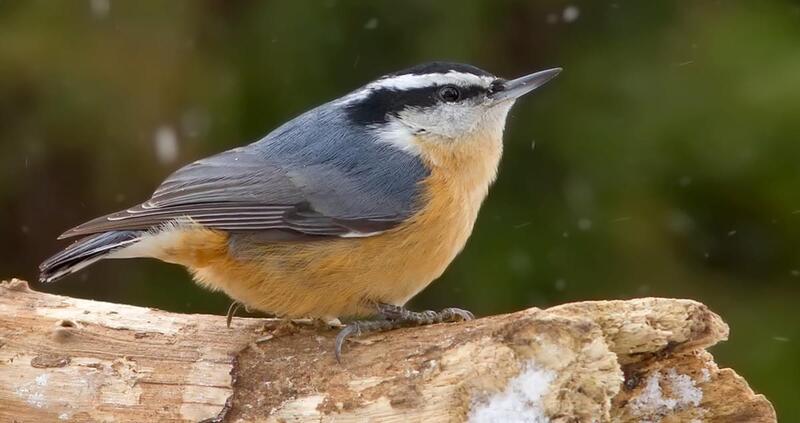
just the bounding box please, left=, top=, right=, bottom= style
left=347, top=84, right=487, bottom=125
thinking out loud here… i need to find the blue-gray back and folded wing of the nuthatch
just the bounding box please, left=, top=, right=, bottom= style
left=61, top=106, right=428, bottom=239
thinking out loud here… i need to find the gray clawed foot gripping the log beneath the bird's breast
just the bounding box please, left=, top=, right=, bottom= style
left=334, top=303, right=475, bottom=363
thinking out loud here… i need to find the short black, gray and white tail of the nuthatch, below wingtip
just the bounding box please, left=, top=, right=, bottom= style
left=39, top=231, right=146, bottom=282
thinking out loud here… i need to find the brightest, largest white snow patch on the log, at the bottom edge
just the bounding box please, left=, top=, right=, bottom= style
left=469, top=363, right=556, bottom=423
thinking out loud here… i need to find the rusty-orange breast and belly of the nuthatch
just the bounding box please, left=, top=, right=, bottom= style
left=184, top=132, right=501, bottom=317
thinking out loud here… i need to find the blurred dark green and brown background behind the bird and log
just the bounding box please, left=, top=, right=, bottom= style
left=0, top=0, right=800, bottom=421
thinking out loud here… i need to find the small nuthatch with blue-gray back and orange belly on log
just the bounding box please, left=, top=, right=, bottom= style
left=39, top=62, right=561, bottom=359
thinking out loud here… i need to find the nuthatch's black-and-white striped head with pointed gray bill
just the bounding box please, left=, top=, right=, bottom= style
left=335, top=62, right=561, bottom=150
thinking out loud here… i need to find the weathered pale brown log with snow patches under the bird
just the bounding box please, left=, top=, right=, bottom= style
left=0, top=279, right=776, bottom=423
